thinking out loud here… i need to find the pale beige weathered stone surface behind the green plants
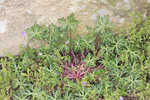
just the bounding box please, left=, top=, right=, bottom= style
left=0, top=0, right=150, bottom=56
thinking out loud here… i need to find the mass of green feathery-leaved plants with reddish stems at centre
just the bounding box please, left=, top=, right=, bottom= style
left=0, top=14, right=150, bottom=100
